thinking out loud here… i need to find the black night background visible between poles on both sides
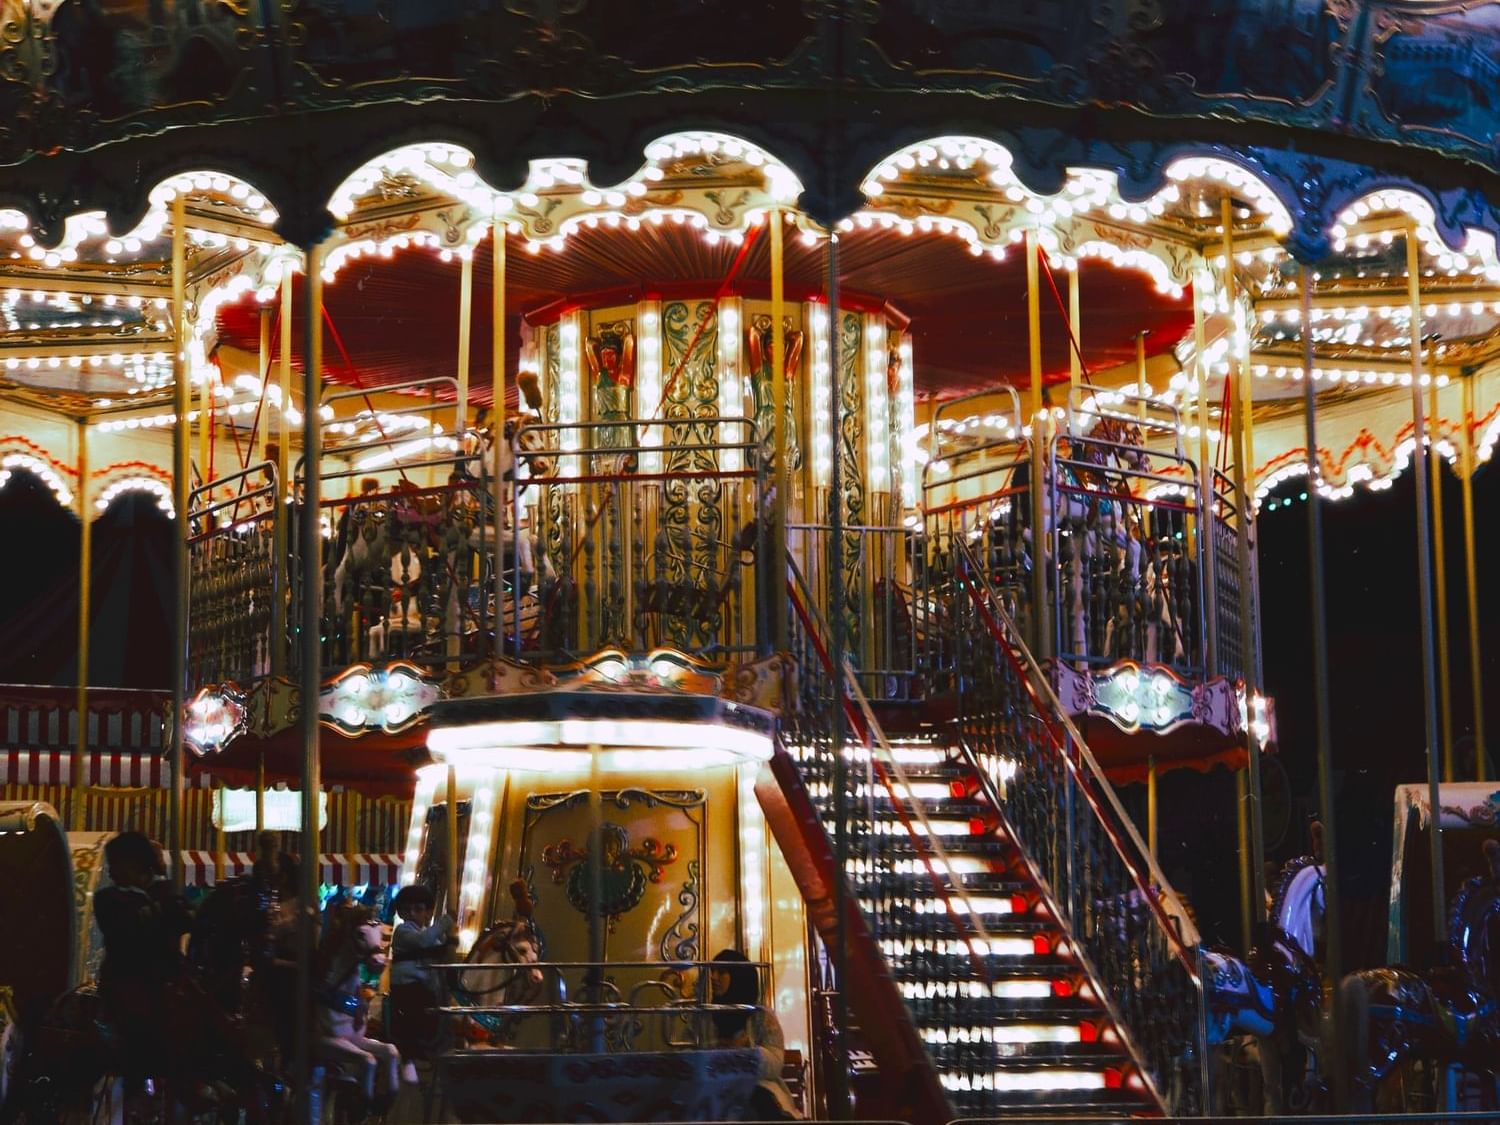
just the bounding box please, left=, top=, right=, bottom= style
left=0, top=467, right=1500, bottom=968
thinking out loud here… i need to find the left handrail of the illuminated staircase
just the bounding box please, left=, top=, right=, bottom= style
left=786, top=558, right=995, bottom=987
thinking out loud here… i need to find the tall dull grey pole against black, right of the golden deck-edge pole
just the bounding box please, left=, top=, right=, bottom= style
left=1302, top=266, right=1344, bottom=1062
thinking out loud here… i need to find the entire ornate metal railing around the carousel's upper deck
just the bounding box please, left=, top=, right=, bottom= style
left=189, top=402, right=1245, bottom=714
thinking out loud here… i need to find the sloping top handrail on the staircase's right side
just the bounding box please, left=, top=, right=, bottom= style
left=954, top=539, right=1202, bottom=960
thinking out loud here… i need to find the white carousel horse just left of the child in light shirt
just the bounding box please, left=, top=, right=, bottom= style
left=314, top=902, right=414, bottom=1107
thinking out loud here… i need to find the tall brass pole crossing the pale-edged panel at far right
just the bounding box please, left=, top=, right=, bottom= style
left=1406, top=224, right=1448, bottom=953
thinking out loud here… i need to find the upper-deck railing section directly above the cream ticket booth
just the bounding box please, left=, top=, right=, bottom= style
left=507, top=416, right=773, bottom=663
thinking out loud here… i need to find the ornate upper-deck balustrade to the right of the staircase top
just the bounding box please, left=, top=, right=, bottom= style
left=915, top=416, right=1244, bottom=680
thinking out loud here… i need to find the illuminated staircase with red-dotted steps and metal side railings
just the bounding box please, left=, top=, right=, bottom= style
left=758, top=552, right=1202, bottom=1122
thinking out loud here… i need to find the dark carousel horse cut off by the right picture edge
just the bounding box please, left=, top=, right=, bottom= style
left=1334, top=840, right=1500, bottom=1112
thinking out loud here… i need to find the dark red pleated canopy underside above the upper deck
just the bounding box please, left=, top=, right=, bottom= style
left=219, top=224, right=1193, bottom=404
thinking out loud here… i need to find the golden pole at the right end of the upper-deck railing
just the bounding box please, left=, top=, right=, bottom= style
left=1220, top=202, right=1266, bottom=923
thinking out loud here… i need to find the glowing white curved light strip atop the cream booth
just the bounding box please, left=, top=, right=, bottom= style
left=428, top=719, right=771, bottom=770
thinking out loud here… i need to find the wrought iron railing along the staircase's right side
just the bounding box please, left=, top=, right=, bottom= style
left=941, top=537, right=1206, bottom=1113
